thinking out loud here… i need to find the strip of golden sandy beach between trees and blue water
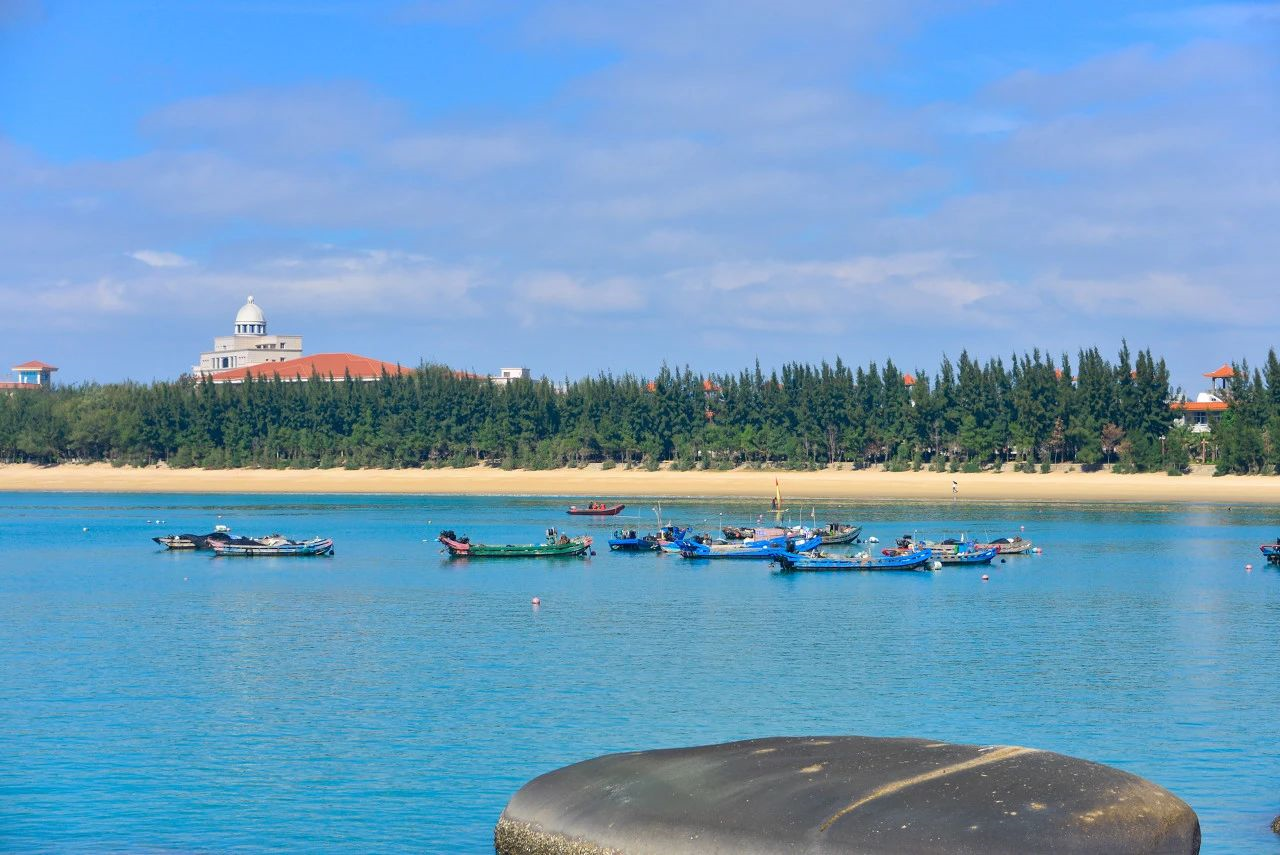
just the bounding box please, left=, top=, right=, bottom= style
left=0, top=463, right=1280, bottom=506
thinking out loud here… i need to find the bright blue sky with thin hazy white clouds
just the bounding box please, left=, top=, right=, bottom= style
left=0, top=0, right=1280, bottom=387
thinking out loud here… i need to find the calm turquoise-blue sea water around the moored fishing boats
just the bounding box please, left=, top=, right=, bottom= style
left=0, top=494, right=1280, bottom=852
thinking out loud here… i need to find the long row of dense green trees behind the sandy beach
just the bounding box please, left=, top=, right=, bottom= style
left=0, top=346, right=1280, bottom=472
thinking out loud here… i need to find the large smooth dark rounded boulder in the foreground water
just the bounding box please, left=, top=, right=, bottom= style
left=494, top=736, right=1199, bottom=855
